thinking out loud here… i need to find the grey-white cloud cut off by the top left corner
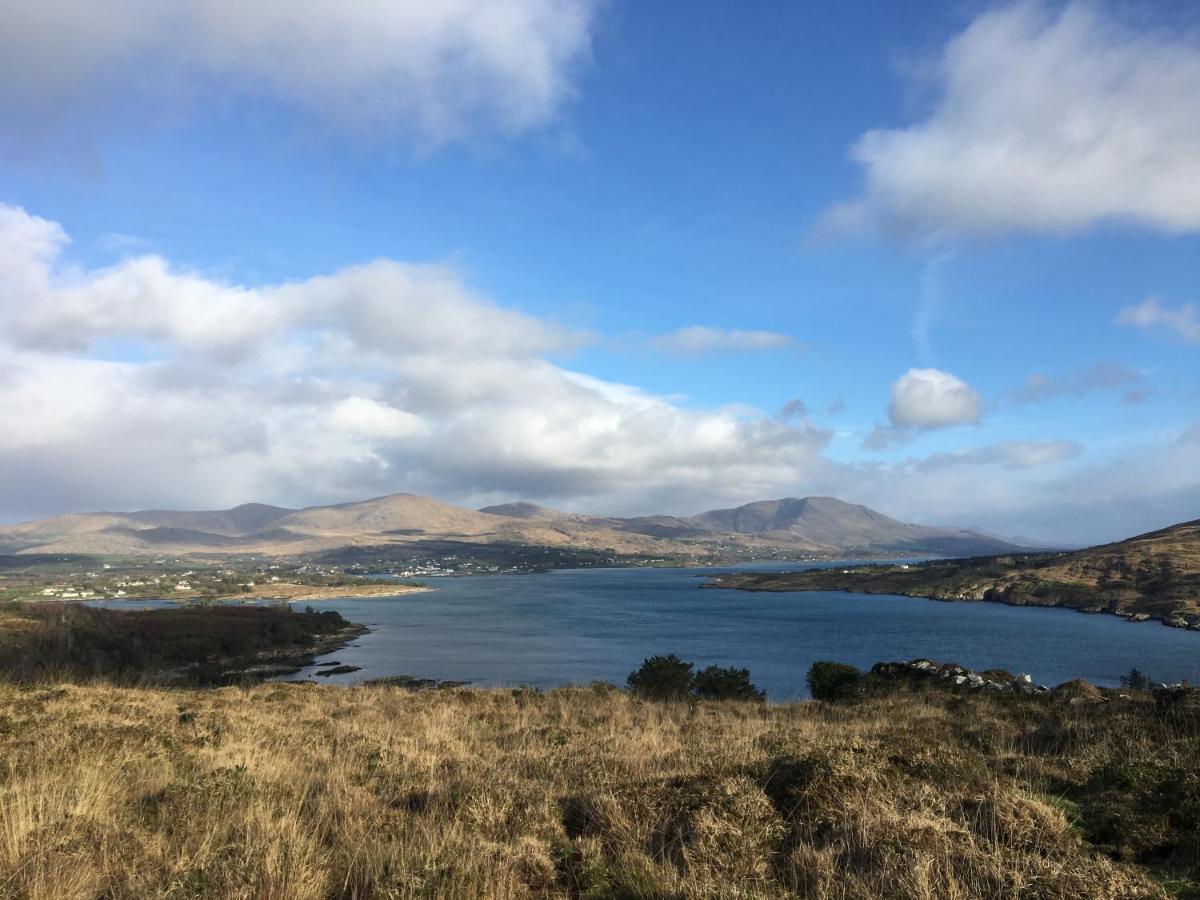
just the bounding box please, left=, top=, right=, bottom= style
left=0, top=0, right=596, bottom=151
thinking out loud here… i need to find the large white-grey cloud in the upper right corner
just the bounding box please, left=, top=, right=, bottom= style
left=821, top=1, right=1200, bottom=235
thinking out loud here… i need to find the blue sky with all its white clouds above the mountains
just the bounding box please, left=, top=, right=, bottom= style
left=0, top=0, right=1200, bottom=544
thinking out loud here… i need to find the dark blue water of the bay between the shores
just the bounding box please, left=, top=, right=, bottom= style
left=91, top=563, right=1200, bottom=701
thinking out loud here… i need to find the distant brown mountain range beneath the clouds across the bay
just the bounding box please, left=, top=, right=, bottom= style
left=0, top=493, right=1019, bottom=557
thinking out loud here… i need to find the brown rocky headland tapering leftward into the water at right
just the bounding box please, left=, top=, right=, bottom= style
left=708, top=521, right=1200, bottom=628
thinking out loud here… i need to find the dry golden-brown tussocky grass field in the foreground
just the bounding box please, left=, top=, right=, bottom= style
left=0, top=684, right=1200, bottom=900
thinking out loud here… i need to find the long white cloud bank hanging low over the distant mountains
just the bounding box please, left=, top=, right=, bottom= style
left=0, top=206, right=829, bottom=517
